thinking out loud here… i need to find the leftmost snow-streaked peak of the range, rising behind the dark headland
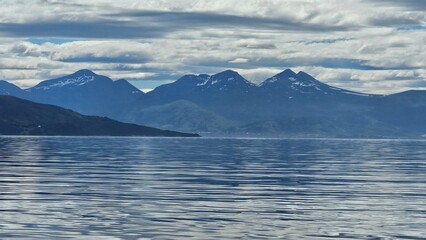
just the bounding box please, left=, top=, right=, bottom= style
left=12, top=69, right=144, bottom=117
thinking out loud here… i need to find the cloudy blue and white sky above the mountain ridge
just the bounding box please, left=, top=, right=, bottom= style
left=0, top=0, right=426, bottom=94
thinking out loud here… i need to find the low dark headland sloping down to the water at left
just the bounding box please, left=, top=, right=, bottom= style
left=0, top=96, right=197, bottom=137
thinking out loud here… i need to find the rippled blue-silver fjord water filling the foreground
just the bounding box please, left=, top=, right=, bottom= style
left=0, top=137, right=426, bottom=239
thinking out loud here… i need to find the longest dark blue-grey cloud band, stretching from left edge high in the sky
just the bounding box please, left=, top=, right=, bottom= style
left=0, top=11, right=354, bottom=39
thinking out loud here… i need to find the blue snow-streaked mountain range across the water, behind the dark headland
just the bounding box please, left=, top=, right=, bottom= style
left=0, top=69, right=426, bottom=138
